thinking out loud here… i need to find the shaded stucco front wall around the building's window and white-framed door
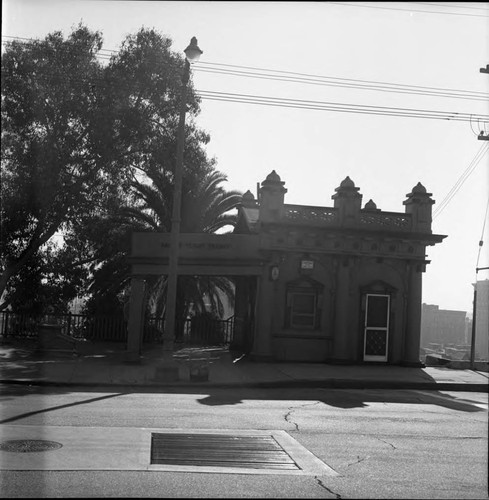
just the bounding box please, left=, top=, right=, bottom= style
left=255, top=252, right=406, bottom=364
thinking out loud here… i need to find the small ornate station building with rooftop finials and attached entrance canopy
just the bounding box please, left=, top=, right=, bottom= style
left=128, top=171, right=445, bottom=366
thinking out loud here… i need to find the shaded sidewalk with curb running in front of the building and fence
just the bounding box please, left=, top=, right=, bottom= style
left=0, top=342, right=489, bottom=392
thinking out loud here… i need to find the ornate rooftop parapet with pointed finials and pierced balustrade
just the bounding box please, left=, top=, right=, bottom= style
left=238, top=171, right=444, bottom=250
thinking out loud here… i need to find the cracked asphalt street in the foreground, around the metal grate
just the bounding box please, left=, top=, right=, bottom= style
left=0, top=385, right=488, bottom=498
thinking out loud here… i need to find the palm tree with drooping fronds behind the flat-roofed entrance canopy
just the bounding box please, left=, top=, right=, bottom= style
left=126, top=165, right=242, bottom=336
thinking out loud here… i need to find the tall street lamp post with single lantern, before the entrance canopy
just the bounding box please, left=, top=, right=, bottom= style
left=163, top=37, right=203, bottom=351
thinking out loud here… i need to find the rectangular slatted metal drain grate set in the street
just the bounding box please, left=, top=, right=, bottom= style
left=151, top=433, right=300, bottom=470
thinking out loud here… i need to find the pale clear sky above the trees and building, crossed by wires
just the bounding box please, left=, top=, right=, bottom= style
left=2, top=0, right=489, bottom=313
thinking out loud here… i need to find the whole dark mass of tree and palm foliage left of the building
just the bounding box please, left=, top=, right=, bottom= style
left=0, top=25, right=239, bottom=312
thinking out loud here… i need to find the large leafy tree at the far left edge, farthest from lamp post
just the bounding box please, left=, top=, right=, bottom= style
left=0, top=26, right=126, bottom=308
